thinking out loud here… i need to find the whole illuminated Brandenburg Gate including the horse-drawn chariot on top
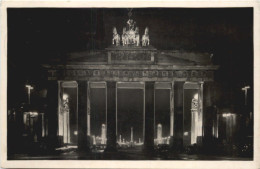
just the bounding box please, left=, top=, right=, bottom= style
left=43, top=19, right=218, bottom=151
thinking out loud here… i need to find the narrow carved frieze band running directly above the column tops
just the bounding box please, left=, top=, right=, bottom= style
left=48, top=69, right=214, bottom=79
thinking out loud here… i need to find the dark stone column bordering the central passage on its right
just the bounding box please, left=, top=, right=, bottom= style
left=144, top=82, right=155, bottom=153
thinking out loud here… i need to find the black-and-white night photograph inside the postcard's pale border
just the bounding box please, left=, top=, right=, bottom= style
left=1, top=0, right=259, bottom=167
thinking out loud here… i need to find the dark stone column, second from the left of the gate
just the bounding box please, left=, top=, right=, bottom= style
left=78, top=81, right=90, bottom=152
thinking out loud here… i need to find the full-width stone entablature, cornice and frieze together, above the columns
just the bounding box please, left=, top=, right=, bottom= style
left=45, top=65, right=218, bottom=81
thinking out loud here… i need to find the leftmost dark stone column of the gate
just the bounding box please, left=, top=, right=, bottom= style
left=46, top=81, right=61, bottom=149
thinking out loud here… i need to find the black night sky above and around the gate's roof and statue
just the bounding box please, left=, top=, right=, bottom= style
left=7, top=8, right=253, bottom=111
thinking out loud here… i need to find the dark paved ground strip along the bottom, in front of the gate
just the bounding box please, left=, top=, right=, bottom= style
left=9, top=150, right=252, bottom=161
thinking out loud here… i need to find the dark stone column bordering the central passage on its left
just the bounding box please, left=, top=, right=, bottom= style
left=105, top=82, right=117, bottom=152
